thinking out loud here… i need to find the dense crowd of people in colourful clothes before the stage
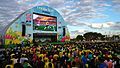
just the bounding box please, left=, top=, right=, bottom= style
left=0, top=43, right=120, bottom=68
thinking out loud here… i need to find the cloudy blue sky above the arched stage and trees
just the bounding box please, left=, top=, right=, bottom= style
left=0, top=0, right=120, bottom=38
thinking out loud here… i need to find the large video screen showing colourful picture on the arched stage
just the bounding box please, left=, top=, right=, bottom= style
left=33, top=13, right=57, bottom=31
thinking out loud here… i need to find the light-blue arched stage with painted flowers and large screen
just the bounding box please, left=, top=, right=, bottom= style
left=2, top=6, right=70, bottom=44
